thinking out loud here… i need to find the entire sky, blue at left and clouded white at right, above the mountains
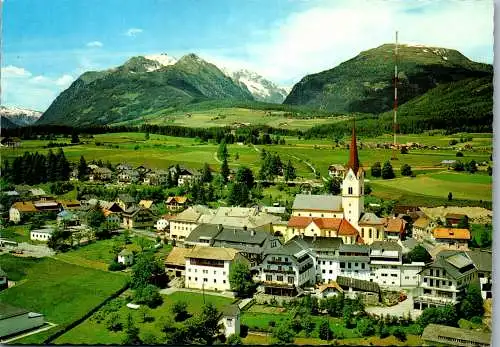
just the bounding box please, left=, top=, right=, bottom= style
left=0, top=0, right=494, bottom=111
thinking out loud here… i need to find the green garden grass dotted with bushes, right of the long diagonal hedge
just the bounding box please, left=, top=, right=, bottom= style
left=55, top=292, right=233, bottom=345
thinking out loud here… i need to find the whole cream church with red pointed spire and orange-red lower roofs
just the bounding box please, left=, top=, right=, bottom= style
left=285, top=126, right=385, bottom=244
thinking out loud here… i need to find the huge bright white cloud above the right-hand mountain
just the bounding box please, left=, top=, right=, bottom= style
left=229, top=0, right=493, bottom=83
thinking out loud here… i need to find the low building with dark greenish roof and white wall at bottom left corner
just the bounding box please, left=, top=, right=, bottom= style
left=0, top=302, right=45, bottom=338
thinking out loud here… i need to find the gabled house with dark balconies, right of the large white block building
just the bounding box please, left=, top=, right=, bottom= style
left=260, top=239, right=316, bottom=296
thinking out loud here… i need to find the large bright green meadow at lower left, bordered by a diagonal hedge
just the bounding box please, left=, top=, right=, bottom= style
left=0, top=255, right=127, bottom=325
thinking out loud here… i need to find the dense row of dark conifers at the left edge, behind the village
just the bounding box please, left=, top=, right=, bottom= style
left=2, top=148, right=71, bottom=185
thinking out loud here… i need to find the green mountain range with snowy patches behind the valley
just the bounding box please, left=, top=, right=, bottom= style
left=37, top=44, right=493, bottom=129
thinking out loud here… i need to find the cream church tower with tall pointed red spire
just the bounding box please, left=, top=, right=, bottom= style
left=342, top=123, right=365, bottom=229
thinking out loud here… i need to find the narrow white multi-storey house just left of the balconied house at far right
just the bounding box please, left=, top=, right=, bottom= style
left=370, top=241, right=403, bottom=287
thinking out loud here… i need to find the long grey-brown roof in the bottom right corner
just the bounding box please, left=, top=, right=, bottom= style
left=422, top=324, right=491, bottom=346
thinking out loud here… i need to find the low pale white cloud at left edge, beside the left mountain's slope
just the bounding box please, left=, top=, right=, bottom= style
left=1, top=66, right=74, bottom=111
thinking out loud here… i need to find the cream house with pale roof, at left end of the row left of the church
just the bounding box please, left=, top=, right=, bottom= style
left=169, top=205, right=213, bottom=240
